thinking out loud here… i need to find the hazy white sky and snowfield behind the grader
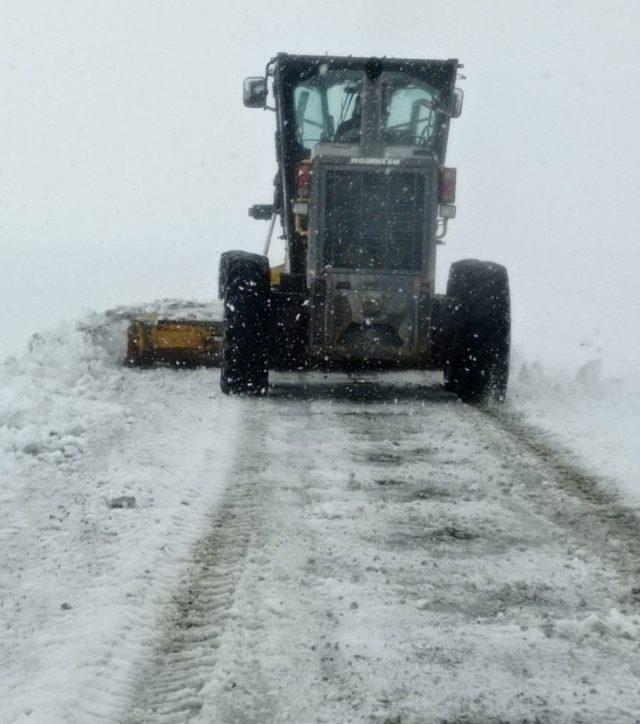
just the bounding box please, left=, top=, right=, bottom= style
left=0, top=0, right=640, bottom=374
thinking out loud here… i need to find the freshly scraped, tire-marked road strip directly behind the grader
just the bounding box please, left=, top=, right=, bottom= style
left=126, top=378, right=640, bottom=722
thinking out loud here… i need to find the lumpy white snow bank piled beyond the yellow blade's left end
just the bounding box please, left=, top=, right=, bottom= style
left=0, top=315, right=127, bottom=473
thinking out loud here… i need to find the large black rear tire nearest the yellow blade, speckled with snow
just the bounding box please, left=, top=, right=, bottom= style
left=220, top=252, right=269, bottom=395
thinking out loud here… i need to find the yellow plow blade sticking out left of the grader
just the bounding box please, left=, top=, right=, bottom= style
left=125, top=319, right=223, bottom=367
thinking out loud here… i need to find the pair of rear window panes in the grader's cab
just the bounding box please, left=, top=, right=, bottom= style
left=293, top=66, right=440, bottom=151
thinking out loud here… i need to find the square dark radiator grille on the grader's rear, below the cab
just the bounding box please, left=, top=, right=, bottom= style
left=324, top=169, right=425, bottom=270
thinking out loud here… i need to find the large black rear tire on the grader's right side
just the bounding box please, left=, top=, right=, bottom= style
left=443, top=259, right=511, bottom=402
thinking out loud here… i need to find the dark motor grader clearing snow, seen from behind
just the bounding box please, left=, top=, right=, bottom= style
left=129, top=53, right=510, bottom=401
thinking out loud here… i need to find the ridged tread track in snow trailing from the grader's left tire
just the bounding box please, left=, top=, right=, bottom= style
left=125, top=408, right=272, bottom=724
